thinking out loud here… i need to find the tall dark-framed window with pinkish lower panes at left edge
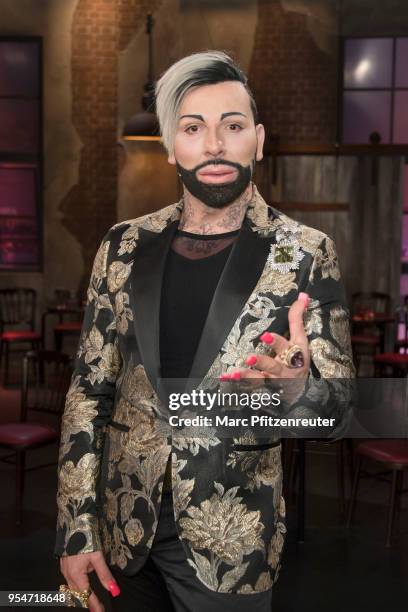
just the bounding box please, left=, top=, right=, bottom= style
left=0, top=38, right=42, bottom=270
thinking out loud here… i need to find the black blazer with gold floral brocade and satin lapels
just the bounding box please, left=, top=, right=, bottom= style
left=55, top=189, right=354, bottom=595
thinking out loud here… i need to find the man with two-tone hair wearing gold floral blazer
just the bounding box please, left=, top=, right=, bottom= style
left=55, top=51, right=353, bottom=612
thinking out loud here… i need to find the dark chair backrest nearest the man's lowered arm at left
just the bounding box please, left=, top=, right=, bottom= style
left=21, top=350, right=72, bottom=422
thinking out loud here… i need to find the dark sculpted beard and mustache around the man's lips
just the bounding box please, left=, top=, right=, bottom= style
left=176, top=160, right=254, bottom=208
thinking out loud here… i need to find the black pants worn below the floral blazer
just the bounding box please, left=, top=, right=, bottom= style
left=111, top=493, right=272, bottom=612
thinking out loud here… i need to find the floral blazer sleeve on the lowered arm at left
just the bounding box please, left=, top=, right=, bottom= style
left=54, top=233, right=121, bottom=556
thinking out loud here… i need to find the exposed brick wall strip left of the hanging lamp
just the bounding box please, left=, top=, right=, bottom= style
left=61, top=0, right=161, bottom=289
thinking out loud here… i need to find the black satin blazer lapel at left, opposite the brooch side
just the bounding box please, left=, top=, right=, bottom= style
left=130, top=221, right=178, bottom=390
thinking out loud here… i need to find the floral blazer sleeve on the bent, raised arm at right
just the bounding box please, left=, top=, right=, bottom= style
left=285, top=236, right=355, bottom=439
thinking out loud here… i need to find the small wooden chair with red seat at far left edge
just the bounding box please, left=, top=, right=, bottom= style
left=0, top=288, right=42, bottom=387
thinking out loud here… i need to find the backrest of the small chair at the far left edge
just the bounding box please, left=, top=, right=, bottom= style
left=0, top=288, right=37, bottom=330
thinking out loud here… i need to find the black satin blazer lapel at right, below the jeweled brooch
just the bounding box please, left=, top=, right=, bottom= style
left=190, top=219, right=271, bottom=388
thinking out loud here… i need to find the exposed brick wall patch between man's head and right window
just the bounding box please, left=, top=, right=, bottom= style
left=249, top=0, right=337, bottom=144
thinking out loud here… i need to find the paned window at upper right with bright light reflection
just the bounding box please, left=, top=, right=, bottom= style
left=341, top=37, right=408, bottom=144
